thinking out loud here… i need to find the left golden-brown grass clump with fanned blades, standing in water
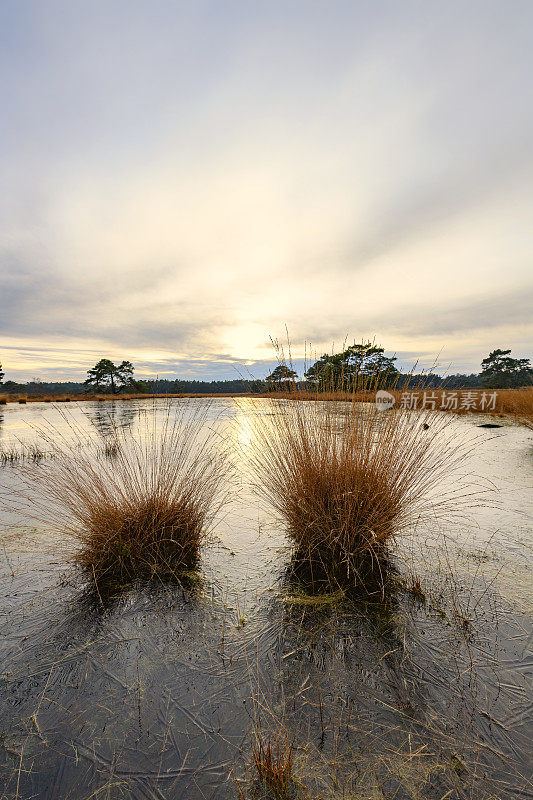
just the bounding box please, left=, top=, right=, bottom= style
left=9, top=402, right=230, bottom=579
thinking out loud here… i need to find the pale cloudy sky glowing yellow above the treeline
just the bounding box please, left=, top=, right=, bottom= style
left=0, top=0, right=533, bottom=380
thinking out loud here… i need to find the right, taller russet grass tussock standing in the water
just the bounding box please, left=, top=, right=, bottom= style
left=245, top=399, right=474, bottom=583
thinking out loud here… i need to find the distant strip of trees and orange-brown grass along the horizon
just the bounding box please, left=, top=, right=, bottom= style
left=0, top=342, right=533, bottom=427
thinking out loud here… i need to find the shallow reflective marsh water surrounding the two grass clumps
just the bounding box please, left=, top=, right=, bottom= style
left=0, top=398, right=533, bottom=800
